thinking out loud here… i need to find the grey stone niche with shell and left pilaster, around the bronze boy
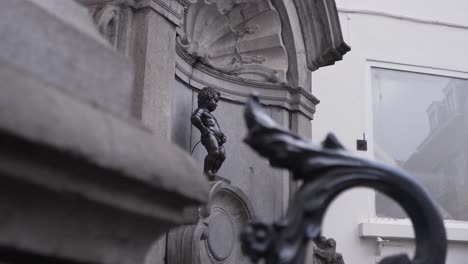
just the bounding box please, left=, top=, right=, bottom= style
left=75, top=0, right=349, bottom=264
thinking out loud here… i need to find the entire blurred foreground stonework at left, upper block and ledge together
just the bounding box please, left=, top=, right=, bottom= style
left=0, top=0, right=209, bottom=263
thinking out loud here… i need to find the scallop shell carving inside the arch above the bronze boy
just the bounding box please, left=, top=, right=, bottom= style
left=179, top=0, right=288, bottom=83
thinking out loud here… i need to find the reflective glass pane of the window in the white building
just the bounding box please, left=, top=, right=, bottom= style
left=372, top=68, right=468, bottom=221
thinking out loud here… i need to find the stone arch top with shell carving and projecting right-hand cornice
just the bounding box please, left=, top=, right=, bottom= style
left=178, top=0, right=350, bottom=91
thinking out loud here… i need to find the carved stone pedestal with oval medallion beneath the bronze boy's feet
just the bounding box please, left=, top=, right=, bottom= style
left=167, top=181, right=255, bottom=264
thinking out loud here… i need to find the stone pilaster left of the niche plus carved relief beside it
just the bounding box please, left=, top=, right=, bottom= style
left=78, top=0, right=185, bottom=139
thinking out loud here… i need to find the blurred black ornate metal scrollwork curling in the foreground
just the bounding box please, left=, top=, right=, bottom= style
left=241, top=96, right=447, bottom=264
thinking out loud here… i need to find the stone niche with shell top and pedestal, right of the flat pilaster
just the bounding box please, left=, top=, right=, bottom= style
left=170, top=0, right=347, bottom=264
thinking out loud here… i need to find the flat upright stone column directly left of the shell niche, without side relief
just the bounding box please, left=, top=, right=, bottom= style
left=133, top=0, right=183, bottom=139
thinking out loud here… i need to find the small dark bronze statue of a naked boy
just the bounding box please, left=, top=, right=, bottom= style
left=191, top=87, right=226, bottom=180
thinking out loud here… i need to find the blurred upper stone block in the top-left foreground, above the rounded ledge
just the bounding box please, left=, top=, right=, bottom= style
left=0, top=0, right=133, bottom=115
